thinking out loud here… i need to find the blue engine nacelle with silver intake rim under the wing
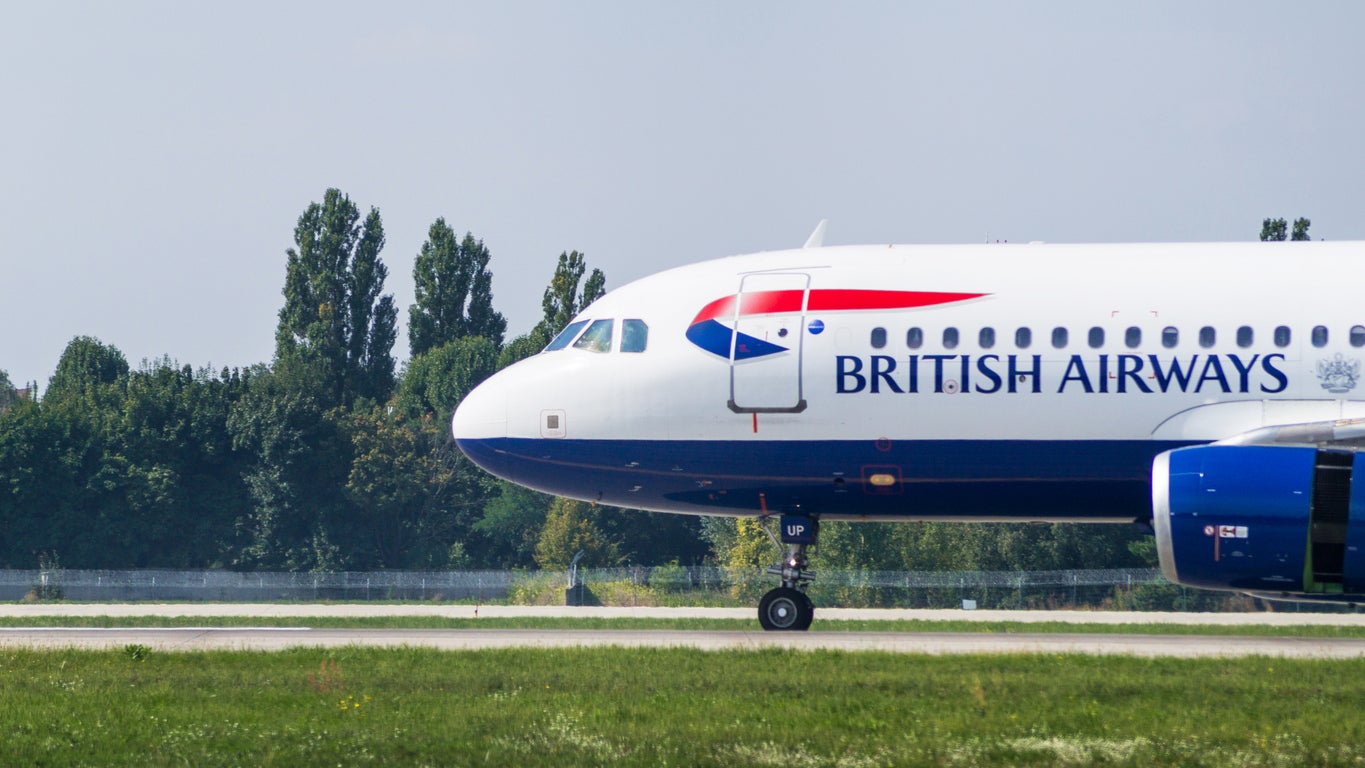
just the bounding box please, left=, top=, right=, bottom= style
left=1152, top=445, right=1365, bottom=602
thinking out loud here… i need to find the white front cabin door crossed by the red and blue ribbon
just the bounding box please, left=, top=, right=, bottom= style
left=729, top=273, right=811, bottom=413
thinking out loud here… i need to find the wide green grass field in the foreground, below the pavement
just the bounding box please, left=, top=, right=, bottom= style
left=0, top=647, right=1365, bottom=768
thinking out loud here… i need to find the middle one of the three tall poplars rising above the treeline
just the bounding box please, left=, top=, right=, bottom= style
left=408, top=218, right=508, bottom=357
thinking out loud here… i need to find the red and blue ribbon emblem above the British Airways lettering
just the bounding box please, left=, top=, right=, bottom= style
left=687, top=288, right=986, bottom=360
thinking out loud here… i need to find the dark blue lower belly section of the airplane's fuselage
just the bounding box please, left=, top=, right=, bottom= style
left=459, top=438, right=1190, bottom=522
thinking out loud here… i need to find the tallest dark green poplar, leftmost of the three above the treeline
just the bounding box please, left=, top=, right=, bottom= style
left=276, top=190, right=397, bottom=405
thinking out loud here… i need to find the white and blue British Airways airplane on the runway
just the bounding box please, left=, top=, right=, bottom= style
left=452, top=230, right=1365, bottom=630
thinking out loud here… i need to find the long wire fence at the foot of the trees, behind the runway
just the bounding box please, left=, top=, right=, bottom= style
left=0, top=566, right=1250, bottom=610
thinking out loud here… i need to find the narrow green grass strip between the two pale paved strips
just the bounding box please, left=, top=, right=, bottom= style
left=8, top=614, right=1365, bottom=638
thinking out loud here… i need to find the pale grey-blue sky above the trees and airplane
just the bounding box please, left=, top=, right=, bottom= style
left=0, top=1, right=1365, bottom=385
